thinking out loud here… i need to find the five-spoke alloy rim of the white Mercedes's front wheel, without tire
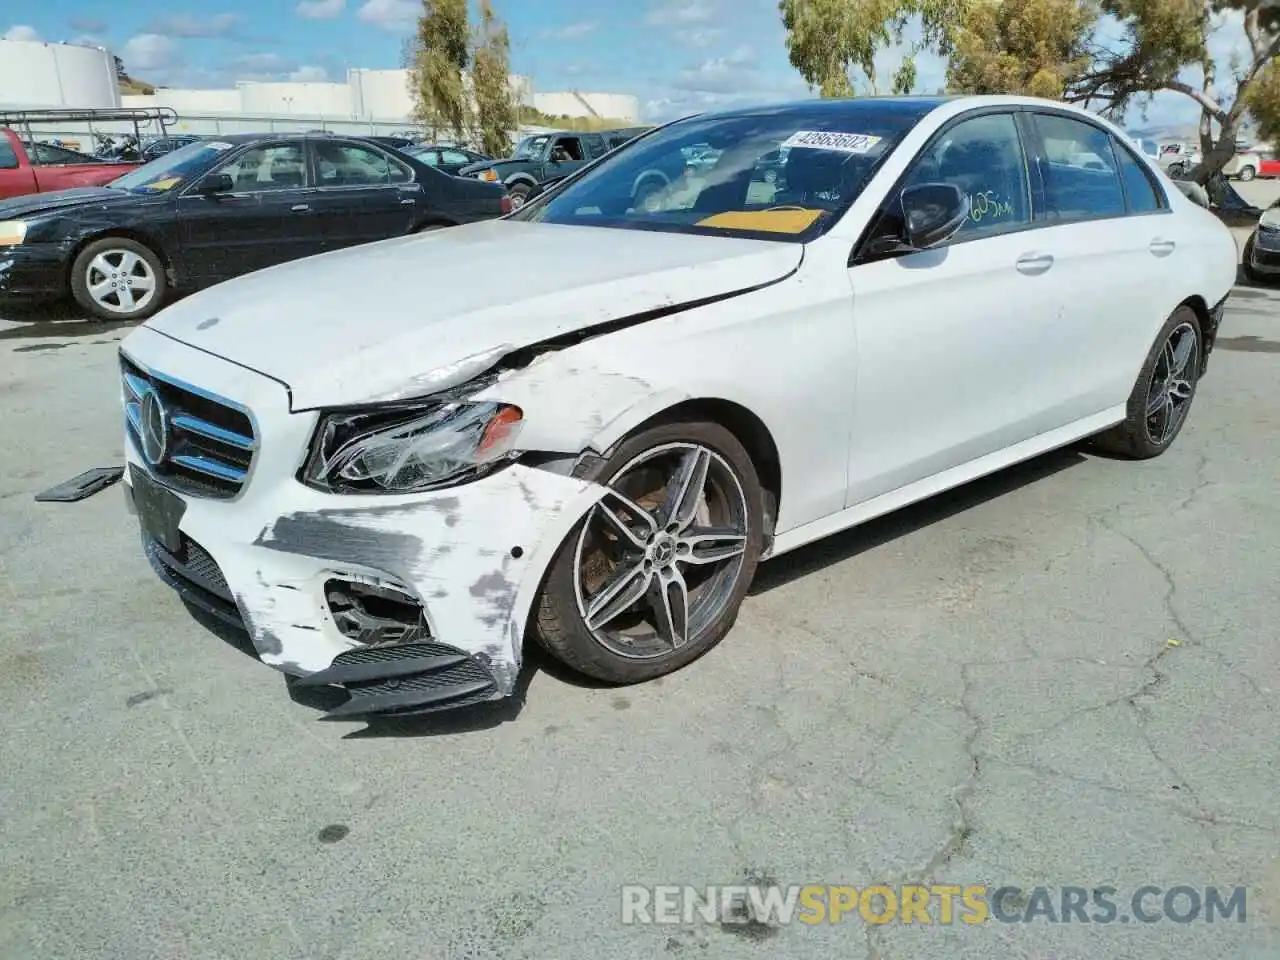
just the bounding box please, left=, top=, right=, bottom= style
left=573, top=442, right=750, bottom=660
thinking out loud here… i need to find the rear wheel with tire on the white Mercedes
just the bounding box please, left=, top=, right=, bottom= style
left=1094, top=307, right=1204, bottom=460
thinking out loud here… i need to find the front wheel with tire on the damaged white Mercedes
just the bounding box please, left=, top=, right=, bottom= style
left=532, top=421, right=764, bottom=685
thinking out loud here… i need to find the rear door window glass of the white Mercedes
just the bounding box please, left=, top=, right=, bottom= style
left=1036, top=114, right=1125, bottom=220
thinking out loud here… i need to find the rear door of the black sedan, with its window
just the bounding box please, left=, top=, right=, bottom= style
left=310, top=137, right=421, bottom=250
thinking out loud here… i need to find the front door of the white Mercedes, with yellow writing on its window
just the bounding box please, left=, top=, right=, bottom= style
left=844, top=111, right=1070, bottom=506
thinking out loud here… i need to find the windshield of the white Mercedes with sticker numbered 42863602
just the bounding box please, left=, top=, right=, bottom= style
left=512, top=104, right=927, bottom=239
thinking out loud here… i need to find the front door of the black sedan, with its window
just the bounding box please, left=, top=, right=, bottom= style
left=178, top=140, right=323, bottom=287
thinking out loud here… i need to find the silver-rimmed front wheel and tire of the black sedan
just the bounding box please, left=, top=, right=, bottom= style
left=70, top=237, right=169, bottom=321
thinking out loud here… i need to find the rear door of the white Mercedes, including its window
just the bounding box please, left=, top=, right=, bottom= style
left=1028, top=110, right=1187, bottom=428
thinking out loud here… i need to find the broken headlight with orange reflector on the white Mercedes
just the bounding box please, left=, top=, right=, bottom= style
left=302, top=402, right=522, bottom=493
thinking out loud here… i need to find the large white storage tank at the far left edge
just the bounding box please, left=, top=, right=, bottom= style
left=0, top=40, right=120, bottom=110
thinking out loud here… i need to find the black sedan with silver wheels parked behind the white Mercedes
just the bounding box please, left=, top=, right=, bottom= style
left=0, top=134, right=511, bottom=320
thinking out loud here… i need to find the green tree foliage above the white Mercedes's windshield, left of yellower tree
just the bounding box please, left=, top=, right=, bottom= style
left=778, top=0, right=964, bottom=97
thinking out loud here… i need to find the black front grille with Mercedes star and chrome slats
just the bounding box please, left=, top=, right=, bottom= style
left=120, top=353, right=257, bottom=499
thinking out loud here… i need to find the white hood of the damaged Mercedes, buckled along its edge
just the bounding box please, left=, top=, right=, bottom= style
left=147, top=220, right=804, bottom=410
